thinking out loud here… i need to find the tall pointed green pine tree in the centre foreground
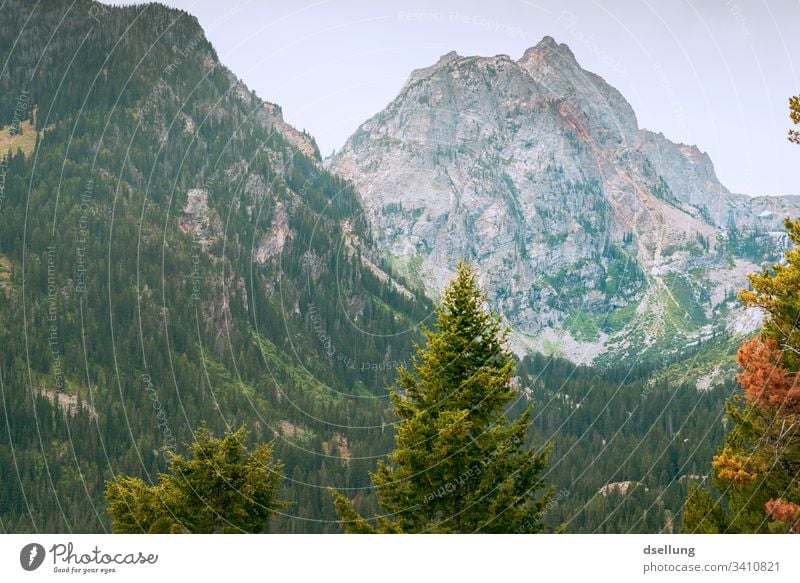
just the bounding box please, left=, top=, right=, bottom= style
left=334, top=263, right=550, bottom=533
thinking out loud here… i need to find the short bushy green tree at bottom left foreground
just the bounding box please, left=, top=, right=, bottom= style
left=106, top=427, right=284, bottom=534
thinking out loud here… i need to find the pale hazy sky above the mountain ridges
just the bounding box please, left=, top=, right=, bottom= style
left=125, top=0, right=800, bottom=195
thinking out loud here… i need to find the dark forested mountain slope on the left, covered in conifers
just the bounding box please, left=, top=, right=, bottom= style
left=0, top=0, right=431, bottom=532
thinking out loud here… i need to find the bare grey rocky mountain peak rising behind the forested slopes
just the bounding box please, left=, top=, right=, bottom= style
left=326, top=37, right=798, bottom=362
